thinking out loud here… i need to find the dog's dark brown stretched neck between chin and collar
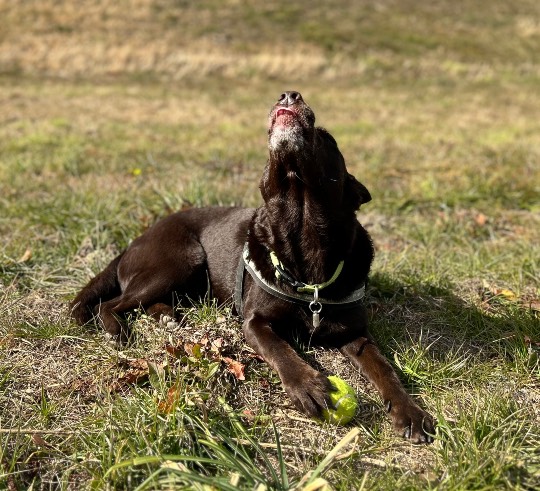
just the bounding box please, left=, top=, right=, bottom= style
left=252, top=152, right=355, bottom=283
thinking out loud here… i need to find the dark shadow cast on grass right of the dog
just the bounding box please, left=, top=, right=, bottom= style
left=366, top=273, right=540, bottom=360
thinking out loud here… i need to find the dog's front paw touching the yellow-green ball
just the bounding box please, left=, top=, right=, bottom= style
left=282, top=367, right=335, bottom=418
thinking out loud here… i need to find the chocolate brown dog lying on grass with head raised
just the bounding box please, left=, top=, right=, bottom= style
left=71, top=91, right=434, bottom=443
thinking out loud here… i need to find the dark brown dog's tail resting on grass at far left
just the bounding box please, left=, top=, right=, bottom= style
left=70, top=252, right=124, bottom=326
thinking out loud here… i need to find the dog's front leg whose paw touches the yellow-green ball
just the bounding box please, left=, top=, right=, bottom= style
left=243, top=315, right=334, bottom=417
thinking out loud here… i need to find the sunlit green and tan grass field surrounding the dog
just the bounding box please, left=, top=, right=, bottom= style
left=0, top=0, right=540, bottom=491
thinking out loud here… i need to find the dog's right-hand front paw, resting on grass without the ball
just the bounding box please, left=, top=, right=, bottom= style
left=386, top=399, right=435, bottom=443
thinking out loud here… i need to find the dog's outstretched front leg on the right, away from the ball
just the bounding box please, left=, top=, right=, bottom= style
left=340, top=337, right=435, bottom=443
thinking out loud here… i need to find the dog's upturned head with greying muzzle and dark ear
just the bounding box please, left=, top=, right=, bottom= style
left=261, top=91, right=371, bottom=210
